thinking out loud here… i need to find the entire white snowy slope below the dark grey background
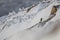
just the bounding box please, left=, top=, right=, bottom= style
left=0, top=1, right=60, bottom=40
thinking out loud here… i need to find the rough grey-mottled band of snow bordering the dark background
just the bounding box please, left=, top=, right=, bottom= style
left=1, top=2, right=52, bottom=29
